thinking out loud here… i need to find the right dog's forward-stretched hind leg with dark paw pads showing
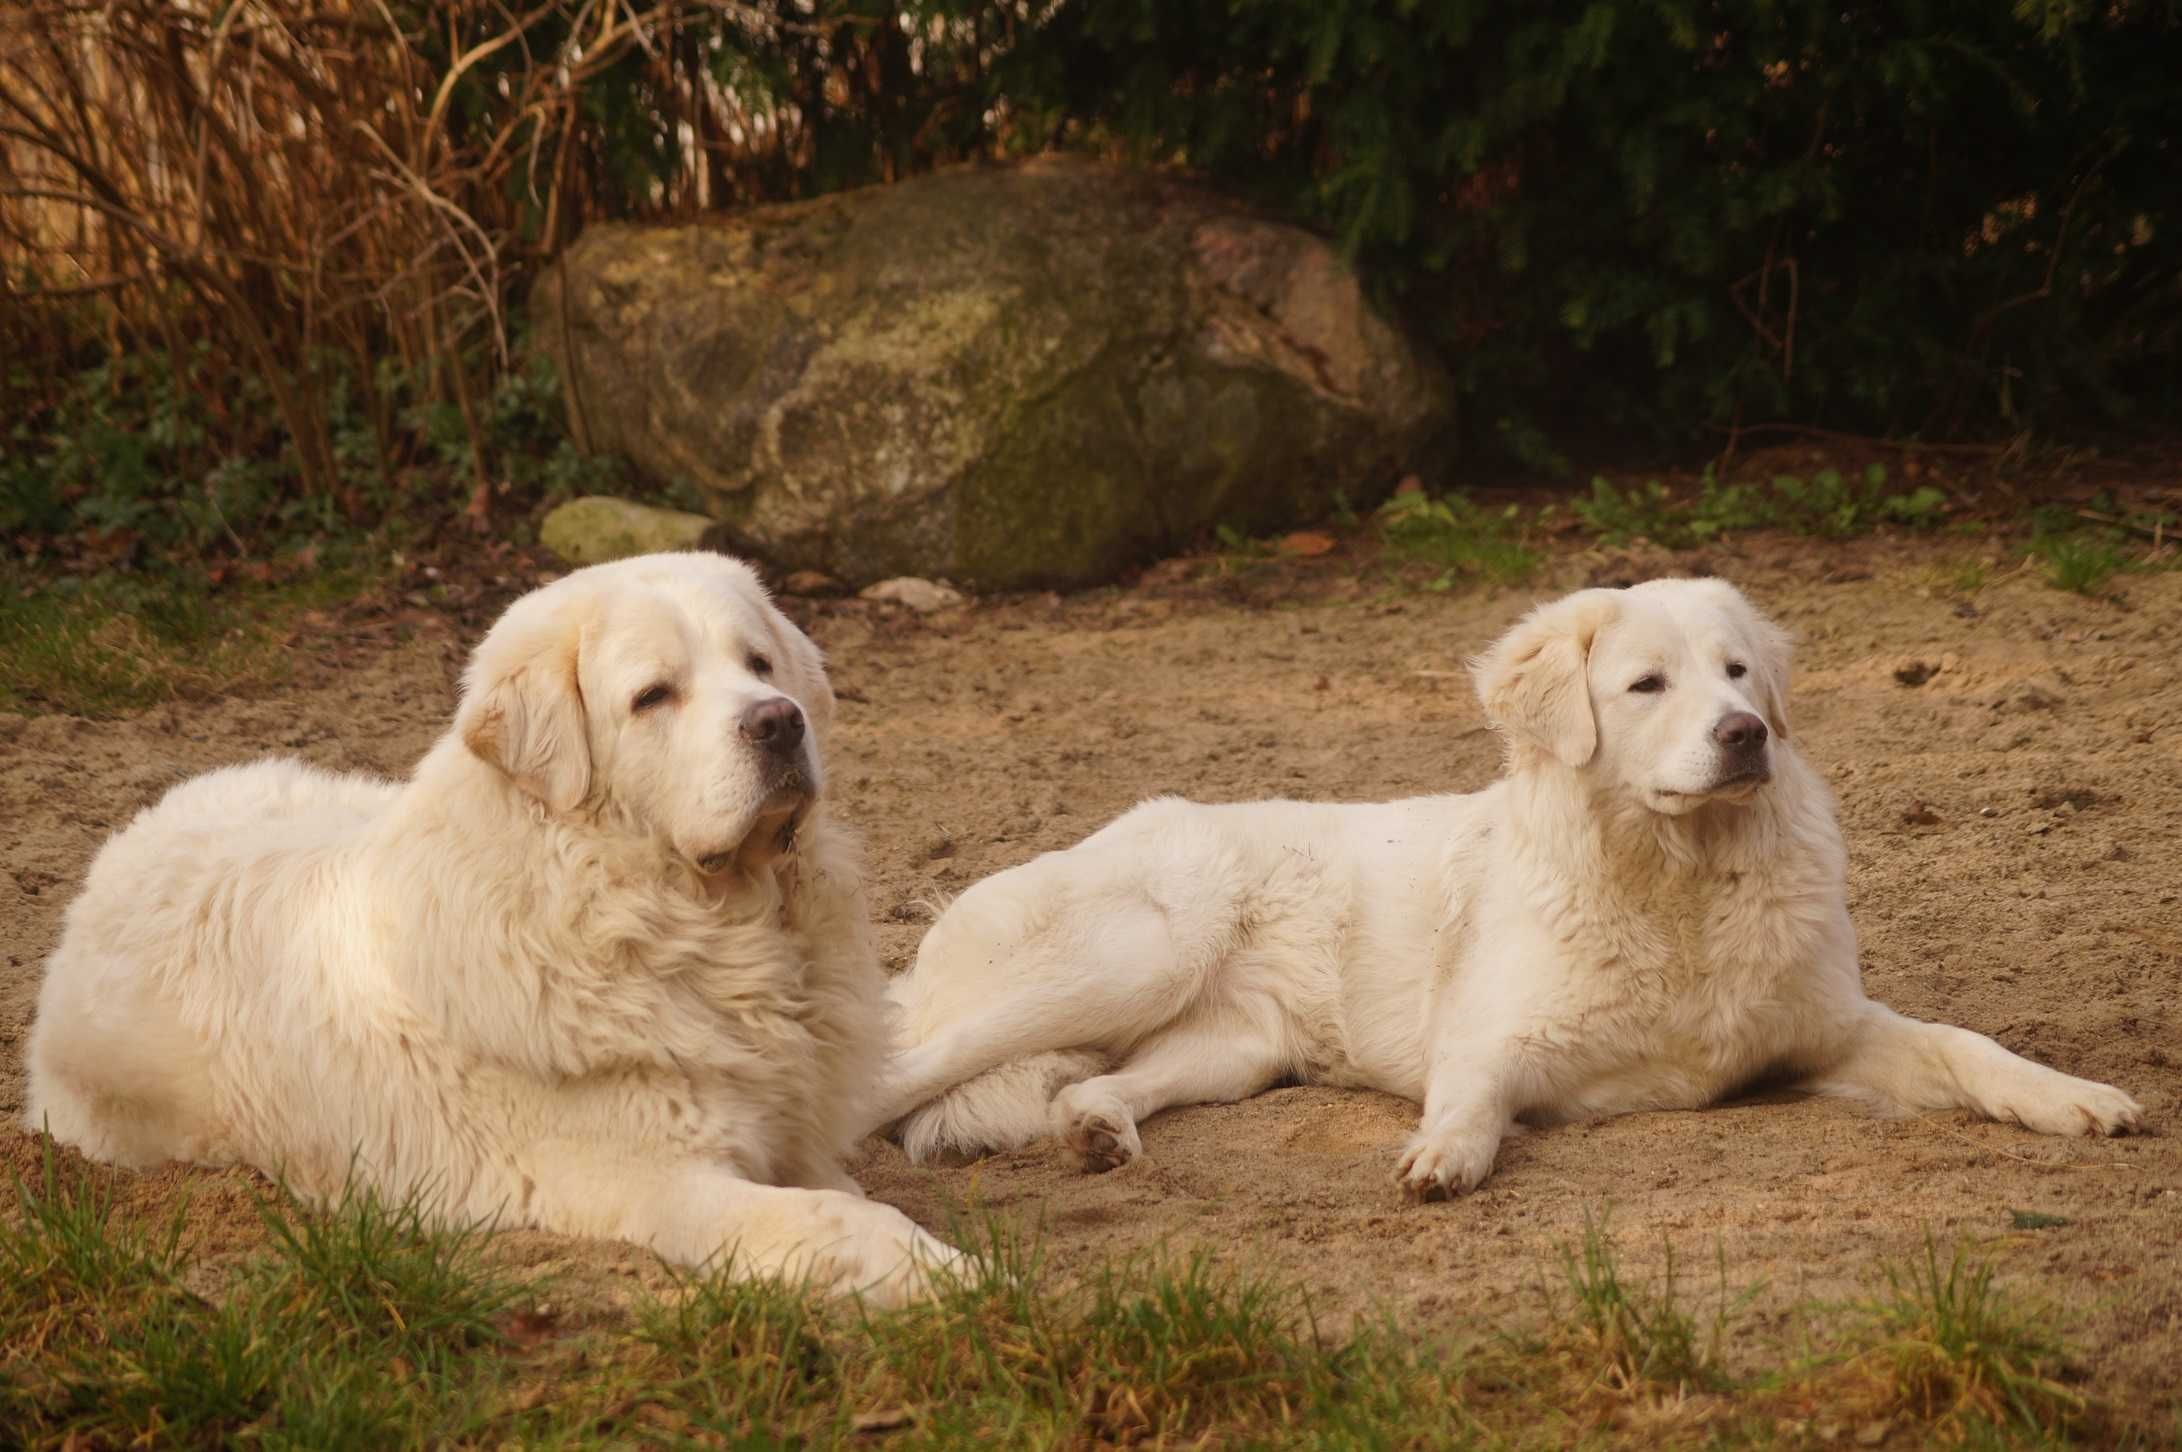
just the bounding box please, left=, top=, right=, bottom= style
left=1052, top=1011, right=1294, bottom=1170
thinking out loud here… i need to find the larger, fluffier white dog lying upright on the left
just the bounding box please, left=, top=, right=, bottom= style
left=26, top=552, right=954, bottom=1301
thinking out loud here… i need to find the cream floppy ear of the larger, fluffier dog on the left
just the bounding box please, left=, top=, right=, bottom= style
left=454, top=605, right=591, bottom=812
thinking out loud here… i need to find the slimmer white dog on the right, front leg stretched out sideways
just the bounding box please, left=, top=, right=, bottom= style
left=879, top=581, right=2141, bottom=1199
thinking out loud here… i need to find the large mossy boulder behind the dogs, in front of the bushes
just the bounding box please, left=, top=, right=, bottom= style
left=532, top=157, right=1447, bottom=587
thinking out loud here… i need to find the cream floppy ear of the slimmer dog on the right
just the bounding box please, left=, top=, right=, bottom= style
left=1471, top=590, right=1619, bottom=766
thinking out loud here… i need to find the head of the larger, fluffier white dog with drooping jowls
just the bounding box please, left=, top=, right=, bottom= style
left=456, top=552, right=834, bottom=873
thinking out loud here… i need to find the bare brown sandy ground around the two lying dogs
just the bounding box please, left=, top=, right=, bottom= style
left=0, top=539, right=2182, bottom=1428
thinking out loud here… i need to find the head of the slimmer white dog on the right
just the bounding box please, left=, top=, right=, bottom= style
left=1473, top=579, right=1789, bottom=814
